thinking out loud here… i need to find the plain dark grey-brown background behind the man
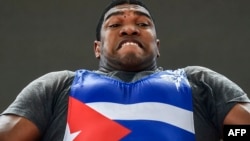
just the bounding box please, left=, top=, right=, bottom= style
left=0, top=0, right=250, bottom=112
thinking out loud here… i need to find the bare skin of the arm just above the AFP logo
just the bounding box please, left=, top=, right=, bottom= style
left=224, top=103, right=250, bottom=125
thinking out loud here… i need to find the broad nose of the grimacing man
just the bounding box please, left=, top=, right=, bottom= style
left=120, top=25, right=140, bottom=36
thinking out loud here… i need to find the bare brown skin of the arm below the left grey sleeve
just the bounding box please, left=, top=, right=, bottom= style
left=0, top=115, right=40, bottom=141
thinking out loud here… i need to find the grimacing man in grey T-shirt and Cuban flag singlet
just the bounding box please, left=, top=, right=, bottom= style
left=0, top=0, right=250, bottom=141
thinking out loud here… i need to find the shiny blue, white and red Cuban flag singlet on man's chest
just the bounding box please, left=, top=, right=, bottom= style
left=64, top=69, right=195, bottom=141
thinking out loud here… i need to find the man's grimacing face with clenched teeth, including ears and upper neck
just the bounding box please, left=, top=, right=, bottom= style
left=94, top=4, right=160, bottom=71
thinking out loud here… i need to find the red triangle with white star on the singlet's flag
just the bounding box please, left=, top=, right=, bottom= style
left=68, top=97, right=130, bottom=141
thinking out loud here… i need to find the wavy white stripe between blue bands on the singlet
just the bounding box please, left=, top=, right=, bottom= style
left=87, top=102, right=194, bottom=133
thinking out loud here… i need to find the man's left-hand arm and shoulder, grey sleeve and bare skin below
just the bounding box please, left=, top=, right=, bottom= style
left=0, top=71, right=74, bottom=141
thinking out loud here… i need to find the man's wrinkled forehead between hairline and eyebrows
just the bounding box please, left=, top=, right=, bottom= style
left=104, top=4, right=152, bottom=21
